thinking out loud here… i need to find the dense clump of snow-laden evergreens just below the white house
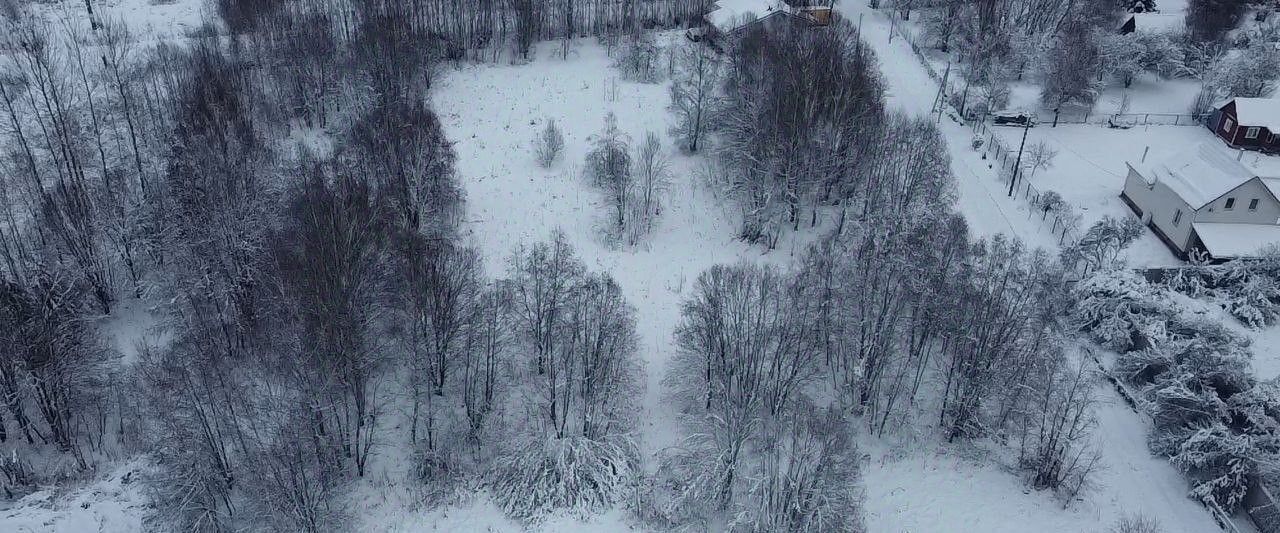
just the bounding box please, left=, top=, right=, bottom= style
left=1073, top=267, right=1280, bottom=511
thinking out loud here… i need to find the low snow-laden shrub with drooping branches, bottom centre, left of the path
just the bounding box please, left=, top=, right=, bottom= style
left=486, top=436, right=639, bottom=521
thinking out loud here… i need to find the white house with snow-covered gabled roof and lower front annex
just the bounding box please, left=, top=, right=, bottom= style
left=1120, top=144, right=1280, bottom=260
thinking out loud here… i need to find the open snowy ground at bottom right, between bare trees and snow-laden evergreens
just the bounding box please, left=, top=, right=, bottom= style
left=864, top=382, right=1220, bottom=533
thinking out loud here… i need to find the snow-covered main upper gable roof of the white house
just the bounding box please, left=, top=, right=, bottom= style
left=1134, top=142, right=1254, bottom=209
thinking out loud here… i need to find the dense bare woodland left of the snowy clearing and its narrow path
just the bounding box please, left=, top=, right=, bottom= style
left=0, top=3, right=650, bottom=530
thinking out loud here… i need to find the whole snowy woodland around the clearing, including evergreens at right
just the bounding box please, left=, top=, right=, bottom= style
left=0, top=0, right=1280, bottom=532
